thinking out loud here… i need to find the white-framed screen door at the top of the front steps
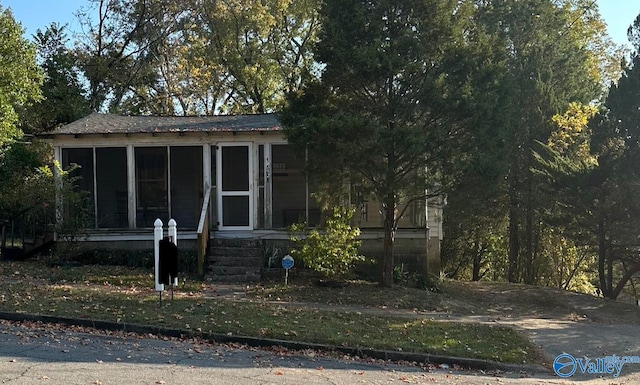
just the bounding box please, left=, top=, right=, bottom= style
left=216, top=142, right=253, bottom=230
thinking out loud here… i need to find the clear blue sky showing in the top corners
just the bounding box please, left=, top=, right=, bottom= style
left=0, top=0, right=640, bottom=44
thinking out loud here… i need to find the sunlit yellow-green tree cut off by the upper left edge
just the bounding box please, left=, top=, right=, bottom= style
left=0, top=7, right=42, bottom=146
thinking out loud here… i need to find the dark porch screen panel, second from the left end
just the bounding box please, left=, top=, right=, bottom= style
left=96, top=147, right=129, bottom=228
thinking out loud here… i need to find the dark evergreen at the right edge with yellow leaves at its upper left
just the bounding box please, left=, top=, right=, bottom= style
left=540, top=10, right=640, bottom=299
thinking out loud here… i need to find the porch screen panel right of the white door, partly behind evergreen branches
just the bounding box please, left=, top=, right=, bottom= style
left=271, top=144, right=320, bottom=228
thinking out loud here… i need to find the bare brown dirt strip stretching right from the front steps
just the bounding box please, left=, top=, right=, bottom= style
left=256, top=281, right=640, bottom=325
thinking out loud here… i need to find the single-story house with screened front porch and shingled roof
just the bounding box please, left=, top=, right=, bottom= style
left=47, top=113, right=442, bottom=278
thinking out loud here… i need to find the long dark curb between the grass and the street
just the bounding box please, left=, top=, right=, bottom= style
left=0, top=312, right=549, bottom=373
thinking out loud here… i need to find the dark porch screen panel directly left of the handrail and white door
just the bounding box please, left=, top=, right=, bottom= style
left=170, top=146, right=204, bottom=229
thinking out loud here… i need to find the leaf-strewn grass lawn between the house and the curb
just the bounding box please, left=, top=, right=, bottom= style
left=0, top=261, right=541, bottom=363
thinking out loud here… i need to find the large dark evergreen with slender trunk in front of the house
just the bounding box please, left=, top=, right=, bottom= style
left=283, top=0, right=486, bottom=287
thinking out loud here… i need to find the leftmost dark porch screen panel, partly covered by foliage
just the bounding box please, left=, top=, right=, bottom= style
left=62, top=148, right=95, bottom=228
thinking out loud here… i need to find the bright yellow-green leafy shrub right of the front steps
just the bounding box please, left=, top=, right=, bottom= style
left=290, top=207, right=365, bottom=279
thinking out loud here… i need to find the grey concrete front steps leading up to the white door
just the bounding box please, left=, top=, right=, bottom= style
left=205, top=238, right=263, bottom=282
